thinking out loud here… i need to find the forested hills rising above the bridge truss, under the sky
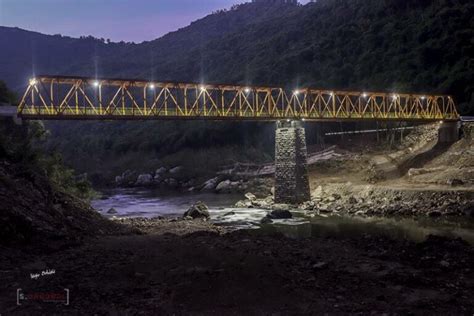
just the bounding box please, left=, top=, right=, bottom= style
left=0, top=0, right=474, bottom=113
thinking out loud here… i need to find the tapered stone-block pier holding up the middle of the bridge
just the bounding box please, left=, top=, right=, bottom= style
left=275, top=121, right=311, bottom=204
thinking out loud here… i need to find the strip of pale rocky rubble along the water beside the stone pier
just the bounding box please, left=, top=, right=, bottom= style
left=236, top=183, right=474, bottom=218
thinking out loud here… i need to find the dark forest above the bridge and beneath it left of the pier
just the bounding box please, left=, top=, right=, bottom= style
left=0, top=0, right=474, bottom=183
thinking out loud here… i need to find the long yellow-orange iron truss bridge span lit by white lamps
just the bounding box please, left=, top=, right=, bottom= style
left=18, top=76, right=459, bottom=121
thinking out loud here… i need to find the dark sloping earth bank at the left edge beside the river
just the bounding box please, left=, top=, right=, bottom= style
left=0, top=160, right=131, bottom=245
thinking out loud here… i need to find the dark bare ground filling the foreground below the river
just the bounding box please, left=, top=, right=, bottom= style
left=0, top=220, right=474, bottom=315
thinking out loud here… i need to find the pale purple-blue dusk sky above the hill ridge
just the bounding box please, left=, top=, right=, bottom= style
left=0, top=0, right=308, bottom=42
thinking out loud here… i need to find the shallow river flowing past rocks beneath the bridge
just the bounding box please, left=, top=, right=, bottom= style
left=92, top=189, right=474, bottom=245
